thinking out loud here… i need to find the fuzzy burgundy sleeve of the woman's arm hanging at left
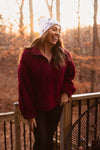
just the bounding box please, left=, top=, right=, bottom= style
left=18, top=51, right=36, bottom=119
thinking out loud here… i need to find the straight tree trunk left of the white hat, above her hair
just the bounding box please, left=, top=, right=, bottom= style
left=29, top=0, right=34, bottom=41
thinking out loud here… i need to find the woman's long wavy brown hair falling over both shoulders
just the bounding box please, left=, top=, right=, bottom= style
left=25, top=31, right=71, bottom=69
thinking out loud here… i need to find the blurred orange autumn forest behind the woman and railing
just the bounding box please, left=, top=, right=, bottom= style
left=0, top=0, right=100, bottom=112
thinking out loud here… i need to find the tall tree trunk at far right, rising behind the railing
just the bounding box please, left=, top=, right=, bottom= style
left=91, top=0, right=98, bottom=92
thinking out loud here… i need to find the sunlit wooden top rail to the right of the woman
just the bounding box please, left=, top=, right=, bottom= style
left=72, top=92, right=100, bottom=100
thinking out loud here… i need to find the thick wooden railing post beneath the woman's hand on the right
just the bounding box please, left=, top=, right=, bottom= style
left=60, top=98, right=72, bottom=150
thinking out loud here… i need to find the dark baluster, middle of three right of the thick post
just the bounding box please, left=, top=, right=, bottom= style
left=86, top=99, right=90, bottom=150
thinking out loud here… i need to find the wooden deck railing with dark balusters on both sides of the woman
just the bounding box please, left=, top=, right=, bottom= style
left=0, top=92, right=100, bottom=150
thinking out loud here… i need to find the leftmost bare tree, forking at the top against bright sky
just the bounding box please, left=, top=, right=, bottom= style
left=16, top=0, right=24, bottom=35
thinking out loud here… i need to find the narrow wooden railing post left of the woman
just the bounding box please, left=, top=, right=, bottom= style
left=14, top=103, right=21, bottom=150
